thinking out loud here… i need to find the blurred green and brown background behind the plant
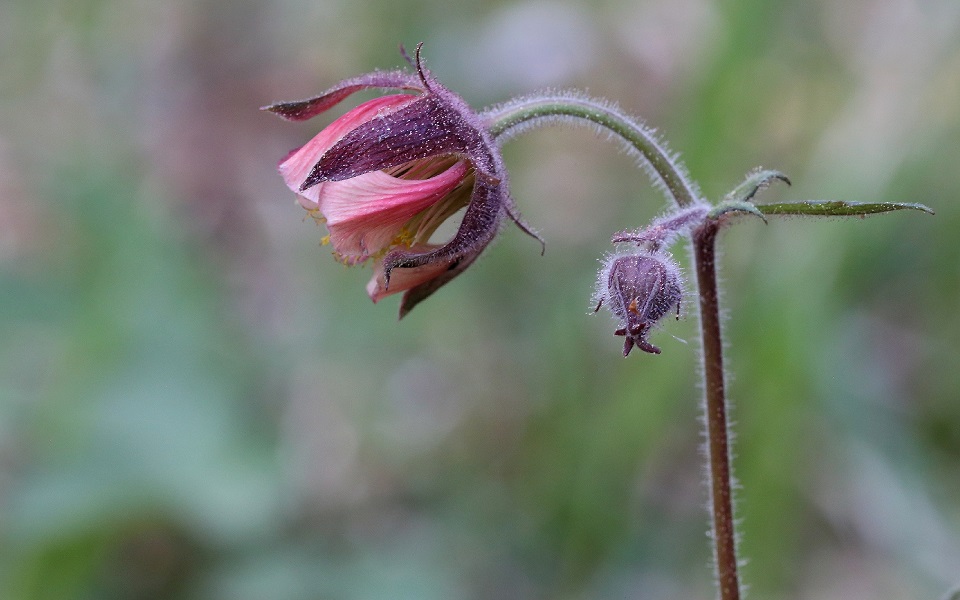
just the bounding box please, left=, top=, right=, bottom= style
left=0, top=0, right=960, bottom=600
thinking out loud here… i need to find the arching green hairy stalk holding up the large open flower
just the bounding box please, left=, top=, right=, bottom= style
left=481, top=94, right=699, bottom=208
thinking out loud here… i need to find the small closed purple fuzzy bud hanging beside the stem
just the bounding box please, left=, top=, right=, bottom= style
left=594, top=251, right=683, bottom=356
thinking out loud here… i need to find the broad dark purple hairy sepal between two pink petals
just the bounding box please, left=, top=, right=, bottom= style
left=301, top=95, right=496, bottom=190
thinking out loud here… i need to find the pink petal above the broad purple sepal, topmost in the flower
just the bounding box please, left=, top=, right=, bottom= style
left=279, top=94, right=417, bottom=198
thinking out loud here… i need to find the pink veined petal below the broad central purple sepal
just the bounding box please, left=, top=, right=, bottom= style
left=316, top=161, right=470, bottom=262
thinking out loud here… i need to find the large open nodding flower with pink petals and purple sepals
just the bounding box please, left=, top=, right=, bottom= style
left=263, top=45, right=539, bottom=317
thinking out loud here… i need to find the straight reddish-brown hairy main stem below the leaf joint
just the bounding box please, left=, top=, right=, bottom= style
left=693, top=219, right=740, bottom=600
